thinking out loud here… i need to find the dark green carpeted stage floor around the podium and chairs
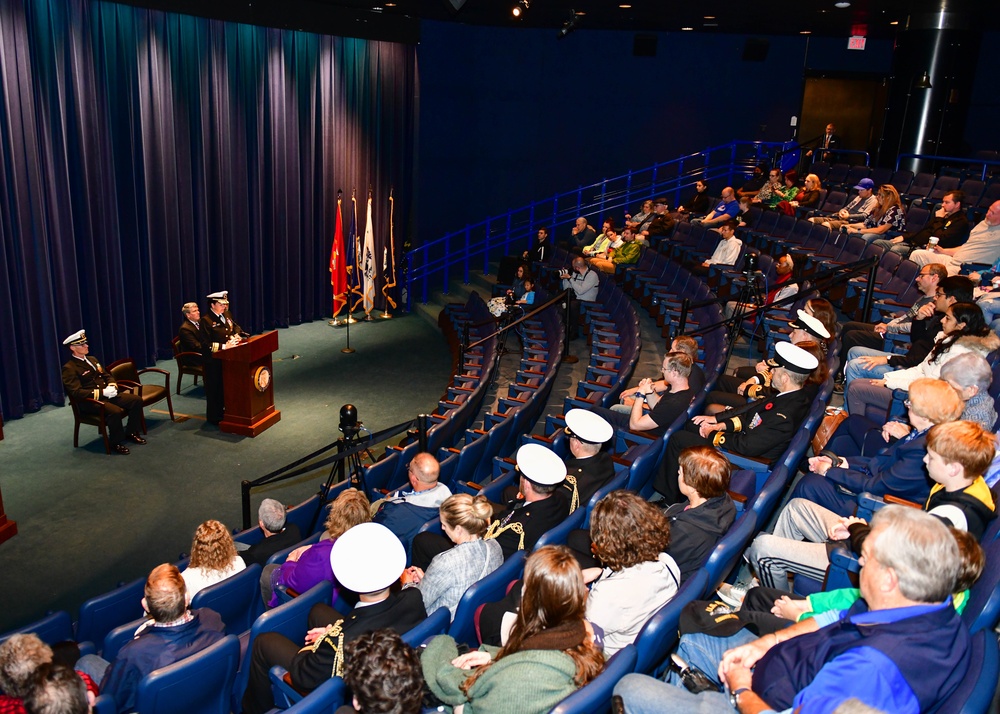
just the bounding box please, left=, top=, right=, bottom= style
left=0, top=313, right=451, bottom=632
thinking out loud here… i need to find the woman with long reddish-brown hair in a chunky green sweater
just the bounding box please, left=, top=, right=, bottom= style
left=420, top=545, right=604, bottom=714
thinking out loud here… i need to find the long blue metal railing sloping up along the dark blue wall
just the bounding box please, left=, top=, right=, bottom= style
left=405, top=141, right=785, bottom=310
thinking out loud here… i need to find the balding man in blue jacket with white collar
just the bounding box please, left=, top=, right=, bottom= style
left=371, top=453, right=451, bottom=548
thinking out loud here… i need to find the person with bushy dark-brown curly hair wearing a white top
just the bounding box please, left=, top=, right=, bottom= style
left=583, top=490, right=681, bottom=657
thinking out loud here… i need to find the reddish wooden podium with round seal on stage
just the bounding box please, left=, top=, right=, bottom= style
left=214, top=330, right=281, bottom=436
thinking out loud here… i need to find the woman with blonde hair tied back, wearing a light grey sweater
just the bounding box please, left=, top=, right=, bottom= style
left=403, top=493, right=503, bottom=618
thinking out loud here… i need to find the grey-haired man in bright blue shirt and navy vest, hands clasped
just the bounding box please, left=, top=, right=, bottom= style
left=615, top=506, right=971, bottom=714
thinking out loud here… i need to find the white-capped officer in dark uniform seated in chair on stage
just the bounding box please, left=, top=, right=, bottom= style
left=63, top=330, right=146, bottom=454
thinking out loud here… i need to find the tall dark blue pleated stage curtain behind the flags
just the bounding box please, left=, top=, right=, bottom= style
left=0, top=0, right=417, bottom=419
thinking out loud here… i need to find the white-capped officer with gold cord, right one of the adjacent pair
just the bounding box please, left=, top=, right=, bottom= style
left=562, top=409, right=615, bottom=513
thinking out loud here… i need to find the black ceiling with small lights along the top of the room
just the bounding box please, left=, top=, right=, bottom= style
left=115, top=0, right=1000, bottom=42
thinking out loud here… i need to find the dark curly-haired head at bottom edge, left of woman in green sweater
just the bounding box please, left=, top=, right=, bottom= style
left=336, top=629, right=424, bottom=714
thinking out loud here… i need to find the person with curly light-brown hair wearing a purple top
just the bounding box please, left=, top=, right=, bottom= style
left=261, top=488, right=371, bottom=607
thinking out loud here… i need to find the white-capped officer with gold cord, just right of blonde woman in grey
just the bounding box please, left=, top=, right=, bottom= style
left=412, top=444, right=569, bottom=571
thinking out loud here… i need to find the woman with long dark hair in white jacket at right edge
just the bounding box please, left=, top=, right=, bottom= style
left=847, top=302, right=1000, bottom=416
